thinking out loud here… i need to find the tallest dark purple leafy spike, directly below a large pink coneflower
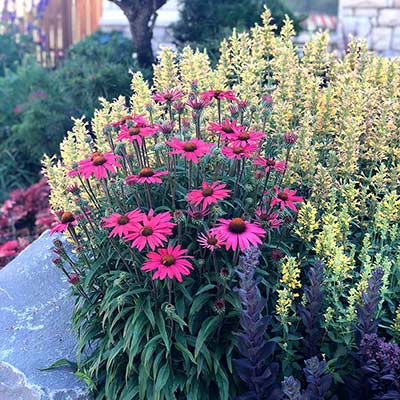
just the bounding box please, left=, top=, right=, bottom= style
left=234, top=247, right=282, bottom=400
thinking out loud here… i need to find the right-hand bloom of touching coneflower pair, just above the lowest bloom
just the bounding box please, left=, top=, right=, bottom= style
left=126, top=210, right=175, bottom=251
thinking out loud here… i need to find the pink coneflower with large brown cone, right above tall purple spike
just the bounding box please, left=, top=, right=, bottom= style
left=212, top=218, right=265, bottom=251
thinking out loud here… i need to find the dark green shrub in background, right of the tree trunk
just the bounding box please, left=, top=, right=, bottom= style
left=173, top=0, right=300, bottom=61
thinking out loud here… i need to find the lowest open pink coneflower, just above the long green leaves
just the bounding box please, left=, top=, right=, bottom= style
left=141, top=244, right=193, bottom=282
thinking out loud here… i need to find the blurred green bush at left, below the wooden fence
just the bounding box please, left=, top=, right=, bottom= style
left=0, top=33, right=135, bottom=199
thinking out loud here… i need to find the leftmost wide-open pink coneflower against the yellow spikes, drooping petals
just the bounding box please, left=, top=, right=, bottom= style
left=77, top=151, right=121, bottom=179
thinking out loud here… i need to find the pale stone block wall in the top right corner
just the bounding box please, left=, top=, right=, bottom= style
left=338, top=0, right=400, bottom=57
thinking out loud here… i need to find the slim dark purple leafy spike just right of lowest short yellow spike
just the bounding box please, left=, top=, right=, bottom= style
left=298, top=261, right=324, bottom=358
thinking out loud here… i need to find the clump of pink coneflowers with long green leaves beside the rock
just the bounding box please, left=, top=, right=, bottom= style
left=46, top=80, right=303, bottom=399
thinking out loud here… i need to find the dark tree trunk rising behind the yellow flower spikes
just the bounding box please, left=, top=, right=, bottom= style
left=110, top=0, right=167, bottom=68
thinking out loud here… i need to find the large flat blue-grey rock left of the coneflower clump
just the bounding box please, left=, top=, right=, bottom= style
left=0, top=232, right=89, bottom=400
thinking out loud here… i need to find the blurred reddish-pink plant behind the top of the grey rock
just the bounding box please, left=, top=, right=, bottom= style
left=0, top=179, right=54, bottom=268
